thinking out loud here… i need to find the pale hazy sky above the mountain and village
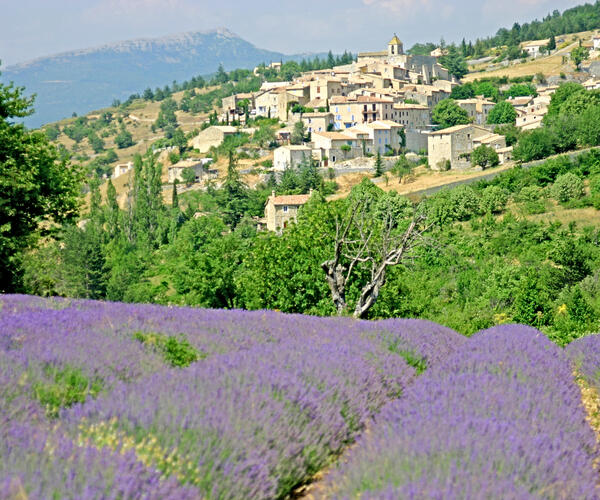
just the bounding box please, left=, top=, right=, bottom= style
left=0, top=0, right=583, bottom=66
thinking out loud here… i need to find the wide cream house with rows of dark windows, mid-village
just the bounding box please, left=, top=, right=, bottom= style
left=329, top=96, right=394, bottom=130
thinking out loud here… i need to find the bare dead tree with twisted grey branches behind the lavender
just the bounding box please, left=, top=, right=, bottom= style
left=321, top=196, right=433, bottom=318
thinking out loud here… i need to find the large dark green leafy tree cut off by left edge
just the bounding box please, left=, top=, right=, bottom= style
left=0, top=71, right=82, bottom=292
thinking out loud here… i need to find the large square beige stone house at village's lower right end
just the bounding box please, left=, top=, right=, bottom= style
left=428, top=124, right=506, bottom=170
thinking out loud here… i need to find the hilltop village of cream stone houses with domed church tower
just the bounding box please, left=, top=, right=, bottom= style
left=103, top=35, right=600, bottom=231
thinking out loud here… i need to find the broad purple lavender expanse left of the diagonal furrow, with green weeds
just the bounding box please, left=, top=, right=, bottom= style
left=0, top=296, right=464, bottom=498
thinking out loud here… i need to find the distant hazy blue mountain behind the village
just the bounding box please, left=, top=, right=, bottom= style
left=0, top=28, right=316, bottom=127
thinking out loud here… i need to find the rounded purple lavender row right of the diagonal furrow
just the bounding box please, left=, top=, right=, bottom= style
left=329, top=325, right=600, bottom=499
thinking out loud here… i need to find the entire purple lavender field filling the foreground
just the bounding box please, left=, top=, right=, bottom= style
left=0, top=295, right=600, bottom=499
